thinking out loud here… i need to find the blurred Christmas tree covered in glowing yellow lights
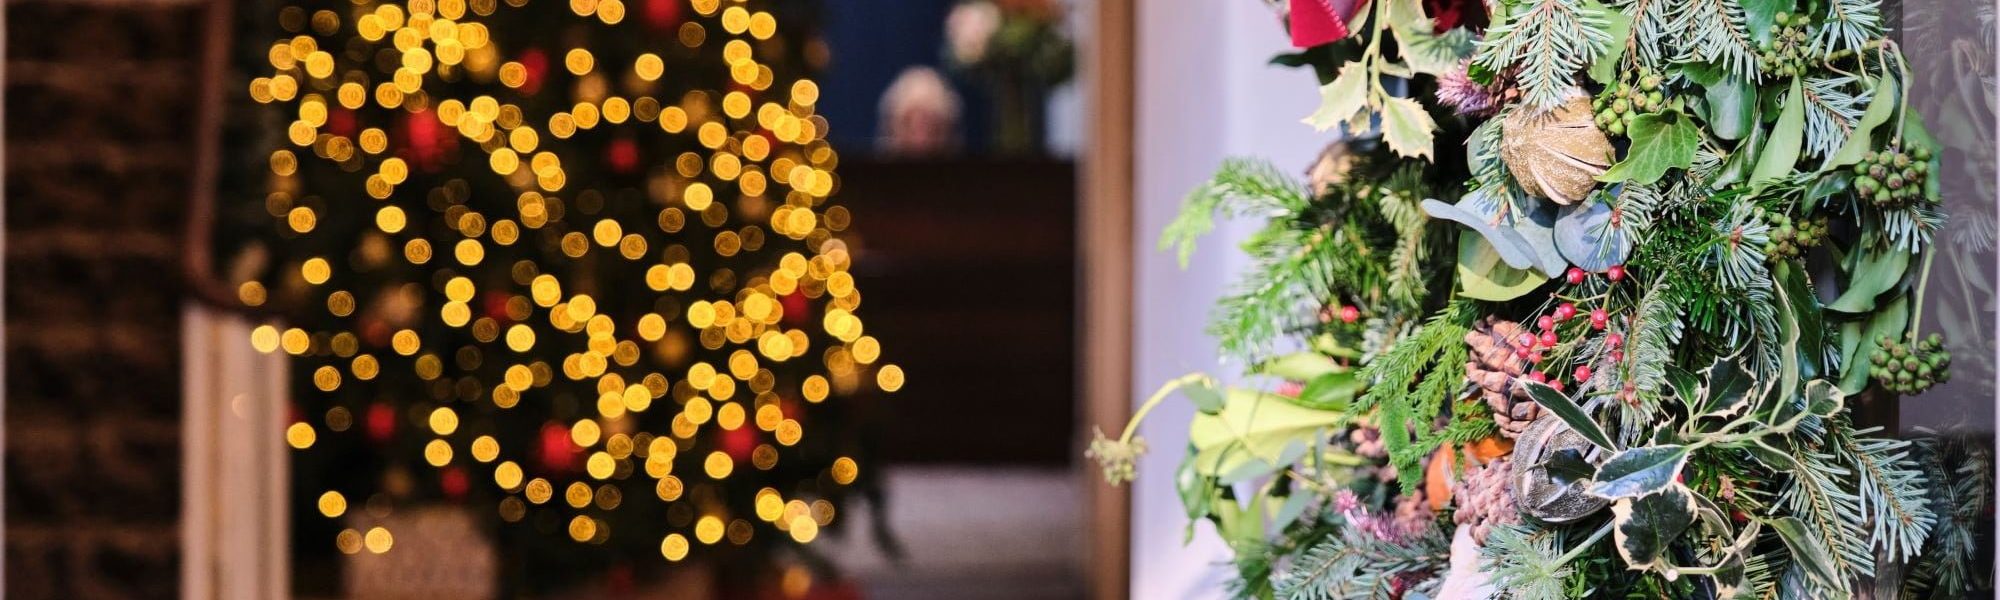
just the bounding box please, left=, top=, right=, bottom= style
left=216, top=0, right=902, bottom=596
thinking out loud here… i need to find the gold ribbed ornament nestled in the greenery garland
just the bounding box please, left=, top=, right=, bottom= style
left=1500, top=96, right=1612, bottom=206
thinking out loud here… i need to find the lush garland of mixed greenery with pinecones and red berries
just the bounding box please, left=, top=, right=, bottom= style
left=1090, top=0, right=1992, bottom=598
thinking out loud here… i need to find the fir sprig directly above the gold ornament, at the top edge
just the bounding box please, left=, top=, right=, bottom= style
left=1472, top=0, right=1612, bottom=110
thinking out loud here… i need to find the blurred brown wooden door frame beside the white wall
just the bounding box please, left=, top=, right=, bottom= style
left=1076, top=0, right=1138, bottom=600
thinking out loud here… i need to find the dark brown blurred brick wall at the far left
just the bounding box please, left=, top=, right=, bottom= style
left=4, top=0, right=202, bottom=600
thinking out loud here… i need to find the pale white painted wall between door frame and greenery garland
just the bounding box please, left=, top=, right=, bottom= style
left=1132, top=0, right=1330, bottom=600
